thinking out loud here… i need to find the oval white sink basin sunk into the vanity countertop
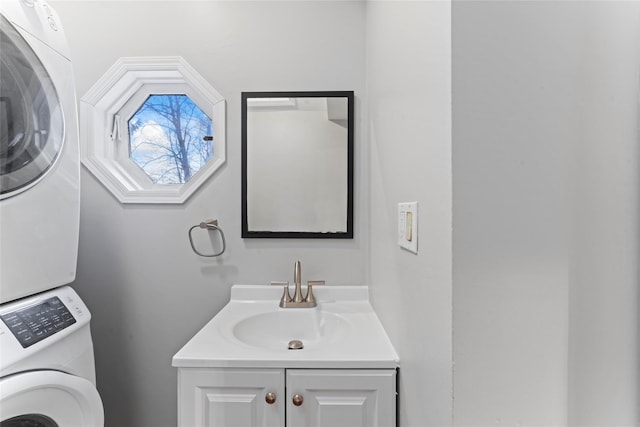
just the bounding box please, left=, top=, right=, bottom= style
left=233, top=308, right=350, bottom=351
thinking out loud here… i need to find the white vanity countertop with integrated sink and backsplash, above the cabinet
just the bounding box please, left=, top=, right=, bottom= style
left=172, top=285, right=399, bottom=369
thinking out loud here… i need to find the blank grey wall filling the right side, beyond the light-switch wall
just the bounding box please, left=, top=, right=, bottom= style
left=453, top=1, right=640, bottom=426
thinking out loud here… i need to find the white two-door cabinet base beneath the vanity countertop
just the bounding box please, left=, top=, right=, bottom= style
left=178, top=368, right=396, bottom=427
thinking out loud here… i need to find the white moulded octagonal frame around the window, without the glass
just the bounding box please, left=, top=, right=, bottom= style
left=80, top=56, right=226, bottom=204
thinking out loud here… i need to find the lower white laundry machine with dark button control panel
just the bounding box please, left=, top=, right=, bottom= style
left=0, top=286, right=104, bottom=427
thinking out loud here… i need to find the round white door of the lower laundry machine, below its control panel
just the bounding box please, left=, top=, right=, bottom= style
left=0, top=371, right=104, bottom=427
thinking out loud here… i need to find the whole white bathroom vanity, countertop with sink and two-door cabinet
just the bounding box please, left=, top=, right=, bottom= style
left=172, top=285, right=400, bottom=427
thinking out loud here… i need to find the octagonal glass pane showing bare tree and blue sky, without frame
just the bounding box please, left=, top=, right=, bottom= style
left=128, top=94, right=213, bottom=184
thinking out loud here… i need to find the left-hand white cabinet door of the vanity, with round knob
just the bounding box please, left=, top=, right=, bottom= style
left=178, top=368, right=286, bottom=427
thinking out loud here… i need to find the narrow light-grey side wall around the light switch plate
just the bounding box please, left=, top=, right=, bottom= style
left=367, top=1, right=452, bottom=427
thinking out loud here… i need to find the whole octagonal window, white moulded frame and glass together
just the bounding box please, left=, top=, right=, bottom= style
left=80, top=57, right=226, bottom=203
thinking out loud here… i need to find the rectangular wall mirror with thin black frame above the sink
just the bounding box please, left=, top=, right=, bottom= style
left=242, top=91, right=354, bottom=239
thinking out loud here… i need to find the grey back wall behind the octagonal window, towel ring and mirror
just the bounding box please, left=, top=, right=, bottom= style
left=52, top=1, right=369, bottom=427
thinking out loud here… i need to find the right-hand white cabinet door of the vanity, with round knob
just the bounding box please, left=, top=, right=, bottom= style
left=287, top=369, right=396, bottom=427
